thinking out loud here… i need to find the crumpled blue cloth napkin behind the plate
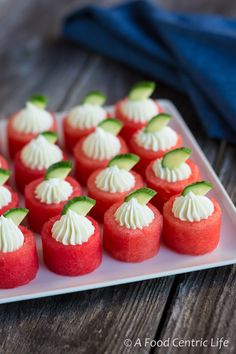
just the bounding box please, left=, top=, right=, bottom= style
left=63, top=0, right=236, bottom=142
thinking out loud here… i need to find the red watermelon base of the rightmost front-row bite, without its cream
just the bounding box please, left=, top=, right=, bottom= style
left=163, top=196, right=221, bottom=255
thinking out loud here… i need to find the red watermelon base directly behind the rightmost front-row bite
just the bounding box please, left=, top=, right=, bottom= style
left=145, top=160, right=202, bottom=211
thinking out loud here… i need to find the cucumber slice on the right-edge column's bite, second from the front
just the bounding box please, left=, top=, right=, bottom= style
left=161, top=147, right=192, bottom=169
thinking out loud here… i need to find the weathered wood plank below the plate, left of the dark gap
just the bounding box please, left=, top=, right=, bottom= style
left=0, top=278, right=173, bottom=354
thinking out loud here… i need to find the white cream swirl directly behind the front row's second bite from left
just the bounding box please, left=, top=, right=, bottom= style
left=35, top=178, right=73, bottom=204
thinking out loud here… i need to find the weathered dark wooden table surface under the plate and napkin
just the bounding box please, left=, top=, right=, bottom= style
left=0, top=0, right=236, bottom=354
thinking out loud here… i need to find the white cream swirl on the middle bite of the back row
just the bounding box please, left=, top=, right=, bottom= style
left=68, top=103, right=107, bottom=129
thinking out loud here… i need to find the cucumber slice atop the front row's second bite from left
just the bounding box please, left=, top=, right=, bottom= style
left=62, top=196, right=96, bottom=216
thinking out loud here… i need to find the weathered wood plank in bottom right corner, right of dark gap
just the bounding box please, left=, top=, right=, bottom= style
left=155, top=266, right=236, bottom=354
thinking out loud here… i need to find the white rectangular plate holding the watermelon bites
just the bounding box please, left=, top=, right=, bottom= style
left=0, top=100, right=236, bottom=303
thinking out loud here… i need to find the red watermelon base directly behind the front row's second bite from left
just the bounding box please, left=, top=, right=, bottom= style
left=25, top=177, right=82, bottom=233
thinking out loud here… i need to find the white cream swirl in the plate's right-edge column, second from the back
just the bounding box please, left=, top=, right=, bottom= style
left=135, top=127, right=178, bottom=151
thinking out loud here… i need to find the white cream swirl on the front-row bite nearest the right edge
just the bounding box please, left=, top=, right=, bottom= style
left=172, top=192, right=214, bottom=222
